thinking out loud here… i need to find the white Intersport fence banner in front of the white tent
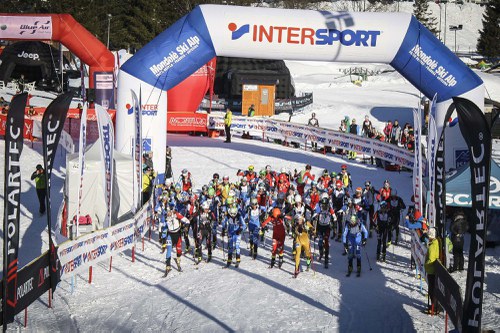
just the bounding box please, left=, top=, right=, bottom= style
left=57, top=219, right=135, bottom=278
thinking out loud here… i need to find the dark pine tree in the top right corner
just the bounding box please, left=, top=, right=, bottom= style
left=477, top=0, right=500, bottom=57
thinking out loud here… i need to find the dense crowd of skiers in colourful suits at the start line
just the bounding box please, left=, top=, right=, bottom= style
left=154, top=164, right=406, bottom=277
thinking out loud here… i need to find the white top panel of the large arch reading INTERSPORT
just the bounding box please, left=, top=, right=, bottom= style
left=200, top=5, right=411, bottom=63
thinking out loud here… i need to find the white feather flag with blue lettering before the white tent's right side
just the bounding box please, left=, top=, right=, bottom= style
left=95, top=104, right=115, bottom=228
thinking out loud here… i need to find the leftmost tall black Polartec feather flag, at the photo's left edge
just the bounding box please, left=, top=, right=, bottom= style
left=2, top=93, right=28, bottom=328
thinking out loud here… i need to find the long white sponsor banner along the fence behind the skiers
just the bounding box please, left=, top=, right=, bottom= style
left=208, top=115, right=414, bottom=169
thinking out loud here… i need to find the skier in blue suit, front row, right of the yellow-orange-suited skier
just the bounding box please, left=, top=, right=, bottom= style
left=342, top=215, right=368, bottom=277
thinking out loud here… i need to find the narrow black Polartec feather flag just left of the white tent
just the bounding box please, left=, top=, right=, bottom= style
left=42, top=92, right=73, bottom=290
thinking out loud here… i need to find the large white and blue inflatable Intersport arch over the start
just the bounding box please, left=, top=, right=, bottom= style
left=116, top=5, right=484, bottom=178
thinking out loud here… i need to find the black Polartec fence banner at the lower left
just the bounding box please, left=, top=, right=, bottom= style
left=0, top=251, right=50, bottom=325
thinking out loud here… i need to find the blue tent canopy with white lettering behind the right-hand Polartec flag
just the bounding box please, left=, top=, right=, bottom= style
left=446, top=160, right=500, bottom=210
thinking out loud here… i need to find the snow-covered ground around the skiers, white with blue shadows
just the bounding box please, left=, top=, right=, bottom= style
left=0, top=2, right=500, bottom=332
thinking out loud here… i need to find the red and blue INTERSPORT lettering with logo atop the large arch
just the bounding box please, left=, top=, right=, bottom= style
left=228, top=23, right=381, bottom=47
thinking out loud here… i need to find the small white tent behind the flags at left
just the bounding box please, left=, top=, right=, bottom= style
left=65, top=140, right=134, bottom=232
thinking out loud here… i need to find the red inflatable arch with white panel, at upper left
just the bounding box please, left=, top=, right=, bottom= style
left=0, top=13, right=115, bottom=108
